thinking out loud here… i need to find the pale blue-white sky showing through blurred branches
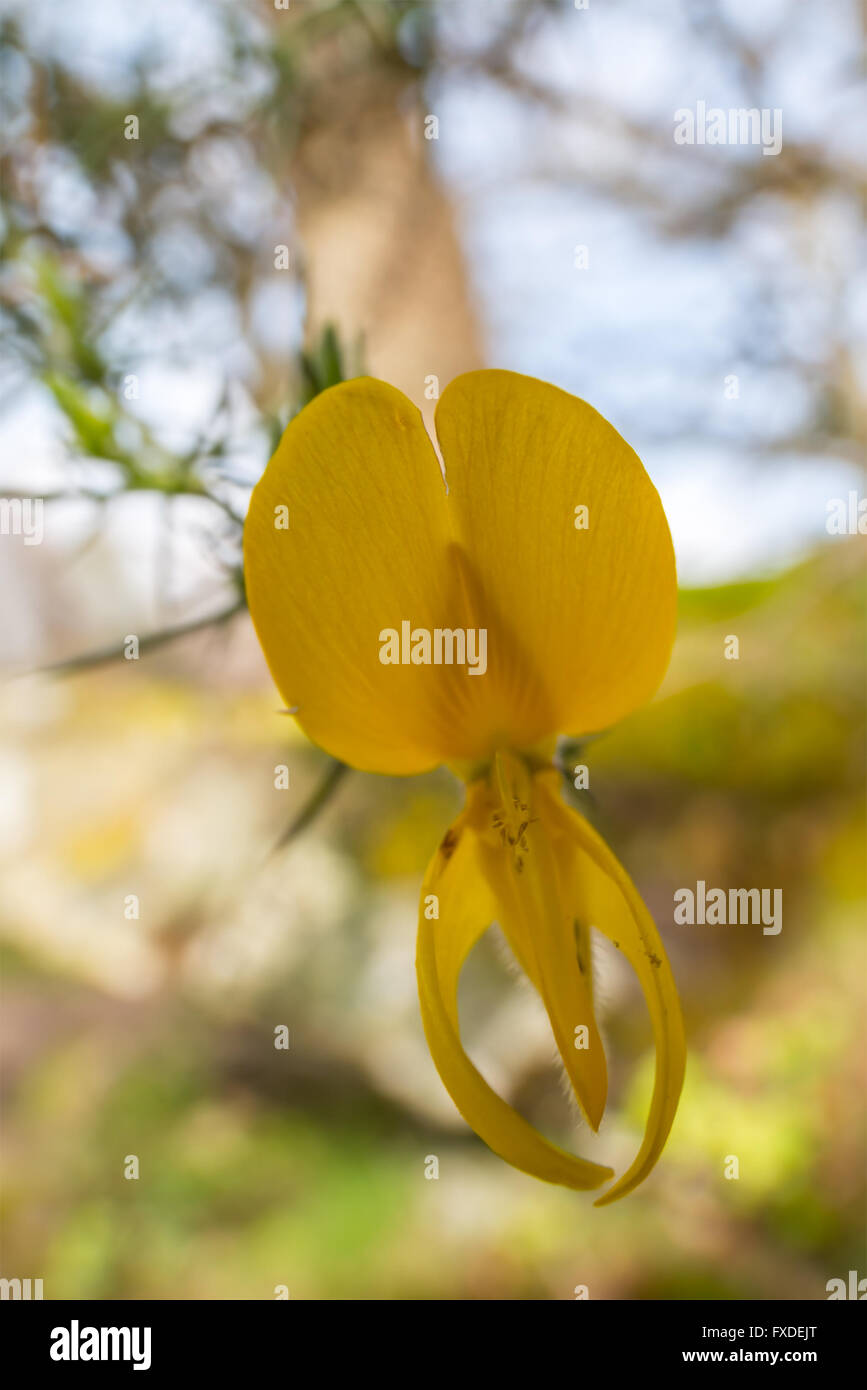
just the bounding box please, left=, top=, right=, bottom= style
left=3, top=0, right=867, bottom=647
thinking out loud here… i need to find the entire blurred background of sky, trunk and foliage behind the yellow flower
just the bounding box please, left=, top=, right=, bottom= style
left=0, top=0, right=867, bottom=1300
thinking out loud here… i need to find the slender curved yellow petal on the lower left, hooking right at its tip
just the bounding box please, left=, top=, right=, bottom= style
left=415, top=812, right=613, bottom=1190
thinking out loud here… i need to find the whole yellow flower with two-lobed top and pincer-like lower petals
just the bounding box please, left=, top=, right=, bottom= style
left=245, top=371, right=685, bottom=1204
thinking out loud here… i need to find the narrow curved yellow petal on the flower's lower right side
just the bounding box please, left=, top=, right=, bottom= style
left=536, top=773, right=686, bottom=1207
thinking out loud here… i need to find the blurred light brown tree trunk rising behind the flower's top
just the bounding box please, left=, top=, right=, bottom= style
left=292, top=64, right=482, bottom=411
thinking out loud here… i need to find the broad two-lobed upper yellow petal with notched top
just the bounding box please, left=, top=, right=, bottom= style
left=245, top=371, right=675, bottom=773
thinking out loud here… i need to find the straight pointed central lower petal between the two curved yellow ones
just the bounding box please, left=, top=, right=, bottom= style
left=472, top=753, right=607, bottom=1130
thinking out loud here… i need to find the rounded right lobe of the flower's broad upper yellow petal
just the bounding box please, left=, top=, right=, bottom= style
left=436, top=371, right=677, bottom=749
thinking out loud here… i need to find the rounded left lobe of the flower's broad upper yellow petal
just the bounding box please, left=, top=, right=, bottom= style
left=245, top=377, right=466, bottom=773
